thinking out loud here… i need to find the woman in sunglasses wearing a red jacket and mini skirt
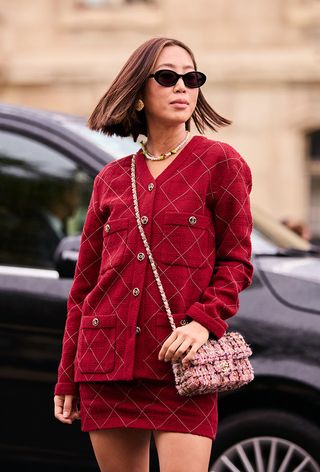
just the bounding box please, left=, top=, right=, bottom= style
left=54, top=38, right=252, bottom=472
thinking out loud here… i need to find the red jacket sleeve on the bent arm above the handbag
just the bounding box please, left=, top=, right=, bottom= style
left=187, top=144, right=253, bottom=338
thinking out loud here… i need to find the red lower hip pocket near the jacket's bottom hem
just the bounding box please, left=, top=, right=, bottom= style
left=77, top=315, right=116, bottom=374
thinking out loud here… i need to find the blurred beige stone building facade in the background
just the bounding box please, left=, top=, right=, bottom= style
left=0, top=0, right=320, bottom=242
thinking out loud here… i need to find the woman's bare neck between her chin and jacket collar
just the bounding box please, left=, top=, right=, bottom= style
left=147, top=123, right=186, bottom=156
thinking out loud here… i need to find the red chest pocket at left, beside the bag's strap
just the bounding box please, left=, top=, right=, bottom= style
left=101, top=218, right=129, bottom=273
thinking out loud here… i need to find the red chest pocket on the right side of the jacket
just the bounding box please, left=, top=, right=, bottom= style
left=159, top=211, right=211, bottom=267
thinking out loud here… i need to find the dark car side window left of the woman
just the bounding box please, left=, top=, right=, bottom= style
left=0, top=131, right=93, bottom=268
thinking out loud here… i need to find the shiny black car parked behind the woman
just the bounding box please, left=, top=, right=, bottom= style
left=0, top=104, right=320, bottom=472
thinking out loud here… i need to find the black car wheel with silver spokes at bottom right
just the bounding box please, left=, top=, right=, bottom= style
left=209, top=410, right=320, bottom=472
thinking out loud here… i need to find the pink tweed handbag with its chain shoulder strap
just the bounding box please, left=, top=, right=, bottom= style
left=131, top=155, right=254, bottom=396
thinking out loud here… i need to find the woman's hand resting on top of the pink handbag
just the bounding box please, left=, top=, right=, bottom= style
left=158, top=320, right=209, bottom=364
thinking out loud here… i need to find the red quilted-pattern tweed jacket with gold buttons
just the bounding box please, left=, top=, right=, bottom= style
left=55, top=136, right=253, bottom=394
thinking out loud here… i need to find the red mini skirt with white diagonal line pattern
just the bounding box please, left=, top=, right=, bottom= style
left=79, top=379, right=218, bottom=439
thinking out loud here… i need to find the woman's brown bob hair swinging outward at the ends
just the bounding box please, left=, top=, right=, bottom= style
left=87, top=38, right=231, bottom=141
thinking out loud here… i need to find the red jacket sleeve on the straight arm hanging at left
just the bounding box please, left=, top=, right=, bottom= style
left=54, top=173, right=106, bottom=395
